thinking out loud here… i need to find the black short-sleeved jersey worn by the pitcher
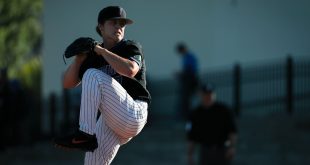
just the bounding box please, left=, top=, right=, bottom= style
left=79, top=39, right=151, bottom=102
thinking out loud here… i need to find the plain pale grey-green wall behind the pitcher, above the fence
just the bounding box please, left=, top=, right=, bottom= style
left=43, top=0, right=310, bottom=97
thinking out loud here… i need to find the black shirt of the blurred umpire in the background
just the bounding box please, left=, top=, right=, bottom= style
left=187, top=102, right=237, bottom=145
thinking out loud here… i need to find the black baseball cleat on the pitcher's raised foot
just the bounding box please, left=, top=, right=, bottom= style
left=54, top=130, right=98, bottom=152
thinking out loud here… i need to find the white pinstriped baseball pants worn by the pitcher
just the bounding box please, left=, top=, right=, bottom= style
left=79, top=69, right=148, bottom=165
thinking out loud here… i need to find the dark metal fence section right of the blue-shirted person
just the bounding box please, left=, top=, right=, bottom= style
left=203, top=56, right=310, bottom=115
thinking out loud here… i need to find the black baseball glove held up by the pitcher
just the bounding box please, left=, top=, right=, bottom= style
left=64, top=37, right=98, bottom=58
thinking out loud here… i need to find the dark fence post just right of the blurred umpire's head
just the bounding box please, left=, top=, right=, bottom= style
left=233, top=64, right=241, bottom=116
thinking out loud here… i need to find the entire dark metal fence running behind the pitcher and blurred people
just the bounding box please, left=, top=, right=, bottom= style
left=46, top=56, right=310, bottom=137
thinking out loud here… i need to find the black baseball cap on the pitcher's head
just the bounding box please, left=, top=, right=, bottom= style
left=98, top=6, right=133, bottom=24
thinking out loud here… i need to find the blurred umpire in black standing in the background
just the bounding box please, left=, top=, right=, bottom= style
left=186, top=84, right=237, bottom=165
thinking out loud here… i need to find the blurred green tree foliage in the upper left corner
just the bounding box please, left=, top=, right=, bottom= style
left=0, top=0, right=43, bottom=92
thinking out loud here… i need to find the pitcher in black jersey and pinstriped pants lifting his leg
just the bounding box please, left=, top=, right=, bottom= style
left=55, top=6, right=150, bottom=165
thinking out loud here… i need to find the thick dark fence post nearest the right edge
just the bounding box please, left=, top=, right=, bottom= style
left=285, top=55, right=294, bottom=114
